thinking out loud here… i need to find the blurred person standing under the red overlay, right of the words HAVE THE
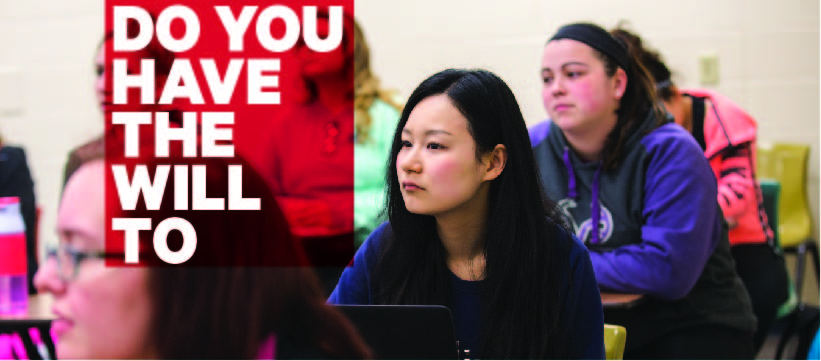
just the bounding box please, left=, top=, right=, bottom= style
left=263, top=9, right=355, bottom=294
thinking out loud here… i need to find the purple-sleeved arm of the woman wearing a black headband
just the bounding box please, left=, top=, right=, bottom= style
left=590, top=135, right=721, bottom=300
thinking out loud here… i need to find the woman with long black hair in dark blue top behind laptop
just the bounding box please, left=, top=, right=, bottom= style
left=329, top=69, right=604, bottom=359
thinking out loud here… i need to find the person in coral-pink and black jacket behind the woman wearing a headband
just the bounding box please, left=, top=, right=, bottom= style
left=610, top=28, right=789, bottom=350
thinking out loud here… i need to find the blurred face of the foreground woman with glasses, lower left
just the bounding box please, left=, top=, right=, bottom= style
left=34, top=161, right=157, bottom=359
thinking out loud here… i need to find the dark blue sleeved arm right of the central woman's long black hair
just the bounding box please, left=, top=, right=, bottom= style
left=565, top=236, right=605, bottom=360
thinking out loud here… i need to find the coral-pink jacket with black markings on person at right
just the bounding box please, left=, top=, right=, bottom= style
left=683, top=89, right=772, bottom=245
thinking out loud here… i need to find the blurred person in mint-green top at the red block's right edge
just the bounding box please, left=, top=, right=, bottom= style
left=354, top=21, right=402, bottom=247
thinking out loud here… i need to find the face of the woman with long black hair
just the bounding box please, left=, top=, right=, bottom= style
left=396, top=94, right=489, bottom=216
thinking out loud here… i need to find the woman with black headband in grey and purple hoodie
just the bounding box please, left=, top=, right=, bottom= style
left=530, top=24, right=755, bottom=359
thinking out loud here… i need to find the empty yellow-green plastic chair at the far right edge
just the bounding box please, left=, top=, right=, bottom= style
left=756, top=143, right=819, bottom=302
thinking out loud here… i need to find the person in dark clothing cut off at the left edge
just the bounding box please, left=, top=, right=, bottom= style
left=0, top=136, right=37, bottom=294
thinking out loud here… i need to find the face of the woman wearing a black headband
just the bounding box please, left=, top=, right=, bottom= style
left=542, top=39, right=626, bottom=134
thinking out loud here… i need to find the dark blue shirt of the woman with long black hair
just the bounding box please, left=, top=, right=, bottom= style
left=328, top=223, right=604, bottom=359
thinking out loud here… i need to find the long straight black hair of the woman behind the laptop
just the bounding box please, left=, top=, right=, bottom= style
left=374, top=69, right=573, bottom=359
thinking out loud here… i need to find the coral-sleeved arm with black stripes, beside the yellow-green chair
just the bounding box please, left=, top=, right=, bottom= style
left=716, top=143, right=756, bottom=223
